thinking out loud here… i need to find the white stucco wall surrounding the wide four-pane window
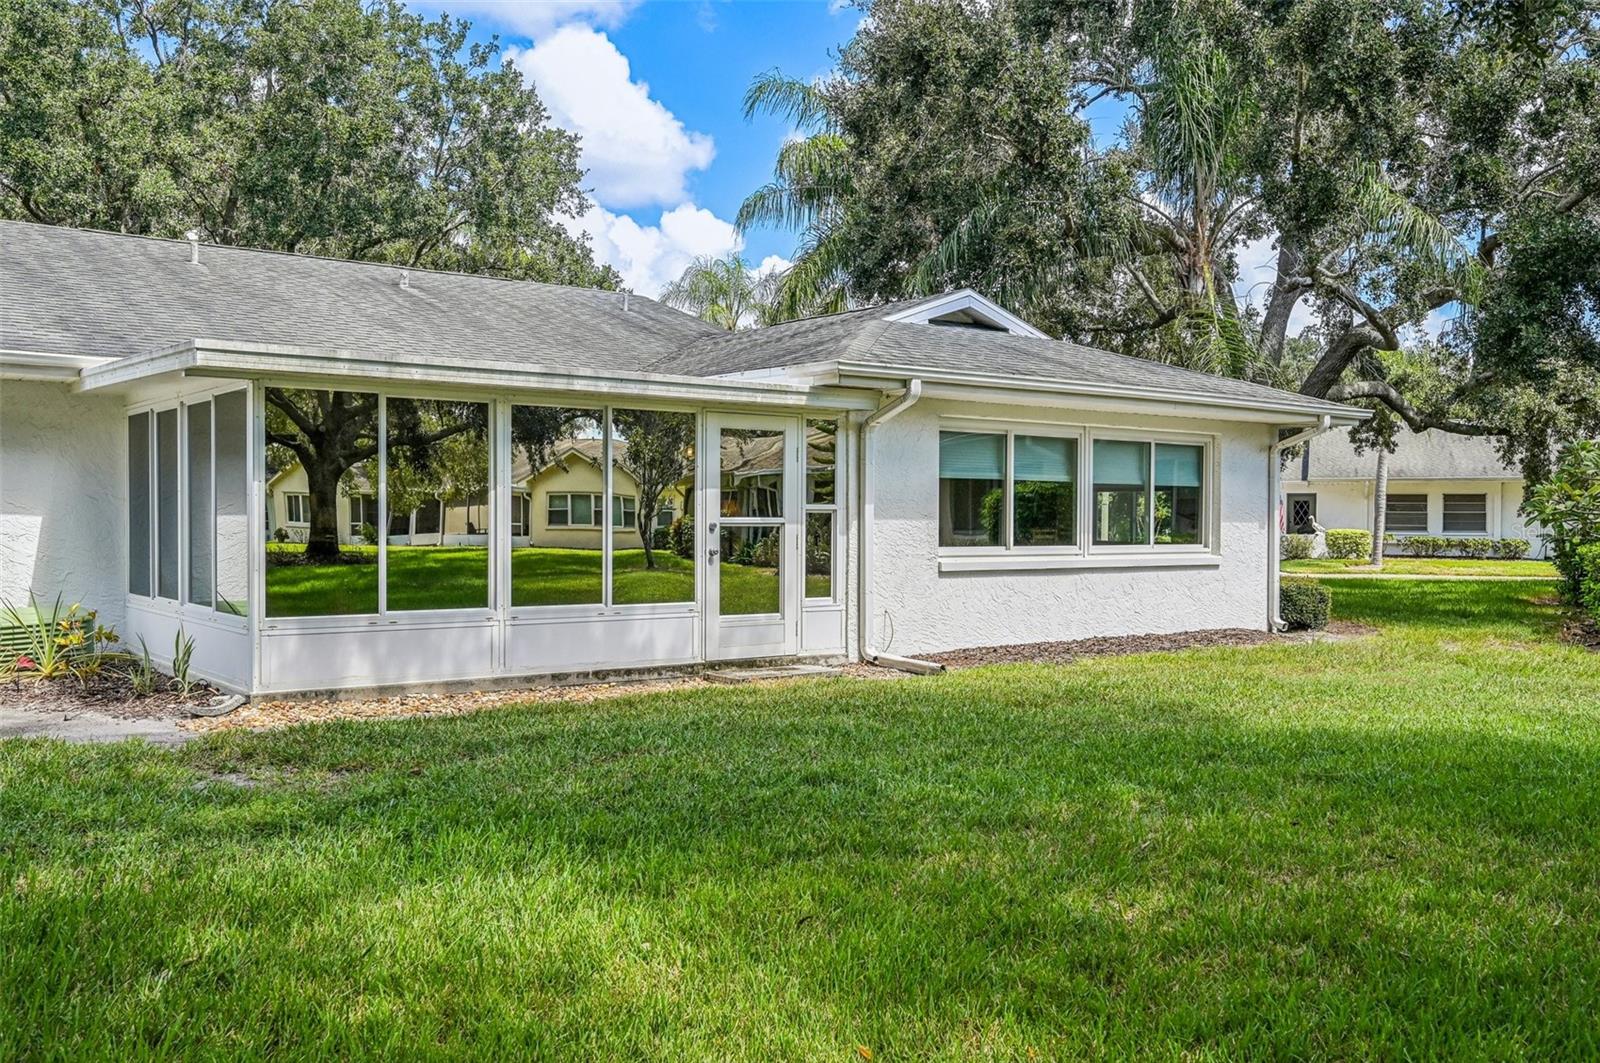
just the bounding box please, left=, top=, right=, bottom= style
left=870, top=400, right=1272, bottom=653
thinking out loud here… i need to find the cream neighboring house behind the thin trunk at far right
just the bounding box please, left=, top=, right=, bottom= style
left=1280, top=429, right=1546, bottom=557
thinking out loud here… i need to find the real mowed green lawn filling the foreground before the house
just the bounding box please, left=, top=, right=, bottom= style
left=0, top=580, right=1600, bottom=1060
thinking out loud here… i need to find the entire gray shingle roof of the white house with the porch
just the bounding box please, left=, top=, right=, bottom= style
left=0, top=221, right=1349, bottom=413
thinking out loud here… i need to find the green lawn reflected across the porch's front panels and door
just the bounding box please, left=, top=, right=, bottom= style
left=267, top=544, right=827, bottom=616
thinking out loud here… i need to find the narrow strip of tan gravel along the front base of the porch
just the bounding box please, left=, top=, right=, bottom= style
left=179, top=676, right=706, bottom=733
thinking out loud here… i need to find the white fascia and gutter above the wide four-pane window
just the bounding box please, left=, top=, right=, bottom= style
left=838, top=362, right=1371, bottom=427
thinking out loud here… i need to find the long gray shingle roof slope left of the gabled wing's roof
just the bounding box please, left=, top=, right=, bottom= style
left=0, top=221, right=717, bottom=371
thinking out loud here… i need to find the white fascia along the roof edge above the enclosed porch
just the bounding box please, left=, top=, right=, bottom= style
left=77, top=339, right=875, bottom=410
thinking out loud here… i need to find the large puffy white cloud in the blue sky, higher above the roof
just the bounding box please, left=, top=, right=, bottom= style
left=506, top=26, right=717, bottom=208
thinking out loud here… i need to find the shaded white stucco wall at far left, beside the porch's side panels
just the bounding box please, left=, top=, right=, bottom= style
left=0, top=379, right=128, bottom=626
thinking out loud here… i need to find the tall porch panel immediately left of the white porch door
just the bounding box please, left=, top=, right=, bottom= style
left=611, top=410, right=694, bottom=605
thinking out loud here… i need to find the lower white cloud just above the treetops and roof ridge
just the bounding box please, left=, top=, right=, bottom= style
left=562, top=203, right=742, bottom=298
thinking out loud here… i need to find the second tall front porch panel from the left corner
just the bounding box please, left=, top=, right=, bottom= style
left=386, top=399, right=491, bottom=612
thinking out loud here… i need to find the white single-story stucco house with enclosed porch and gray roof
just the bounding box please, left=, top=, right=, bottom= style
left=0, top=221, right=1366, bottom=693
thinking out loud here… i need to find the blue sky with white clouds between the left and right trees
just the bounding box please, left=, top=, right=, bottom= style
left=411, top=0, right=861, bottom=295
